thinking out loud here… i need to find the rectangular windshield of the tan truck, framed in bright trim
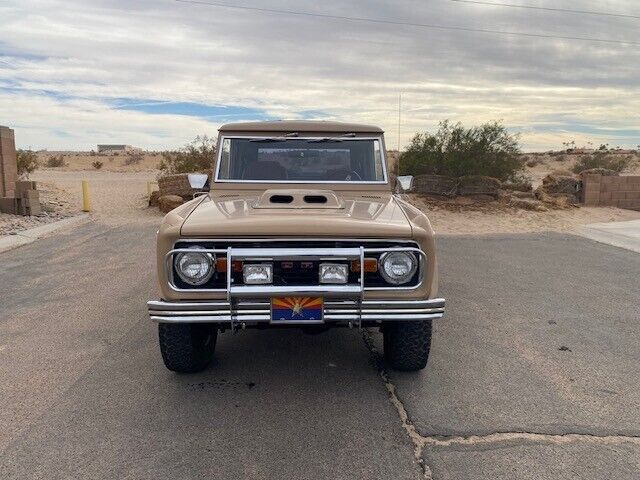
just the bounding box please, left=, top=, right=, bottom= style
left=217, top=137, right=386, bottom=183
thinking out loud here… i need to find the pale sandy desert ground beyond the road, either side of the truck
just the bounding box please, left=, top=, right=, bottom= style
left=0, top=148, right=640, bottom=234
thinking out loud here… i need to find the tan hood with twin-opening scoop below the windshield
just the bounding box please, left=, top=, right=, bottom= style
left=181, top=190, right=412, bottom=239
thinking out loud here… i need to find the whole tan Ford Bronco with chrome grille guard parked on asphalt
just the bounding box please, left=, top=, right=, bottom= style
left=148, top=121, right=445, bottom=372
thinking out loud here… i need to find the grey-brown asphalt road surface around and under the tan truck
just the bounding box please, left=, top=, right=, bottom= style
left=0, top=219, right=640, bottom=480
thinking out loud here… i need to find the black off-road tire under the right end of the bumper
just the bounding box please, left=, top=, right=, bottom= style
left=382, top=320, right=431, bottom=372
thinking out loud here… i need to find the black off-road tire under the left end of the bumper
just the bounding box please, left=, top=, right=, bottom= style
left=158, top=323, right=218, bottom=373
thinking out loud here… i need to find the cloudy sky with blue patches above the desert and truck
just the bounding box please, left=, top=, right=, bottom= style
left=0, top=0, right=640, bottom=150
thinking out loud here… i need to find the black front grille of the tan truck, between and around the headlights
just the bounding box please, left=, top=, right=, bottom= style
left=171, top=240, right=422, bottom=289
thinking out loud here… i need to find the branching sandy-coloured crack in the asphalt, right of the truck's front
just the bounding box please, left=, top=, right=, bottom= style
left=362, top=330, right=640, bottom=480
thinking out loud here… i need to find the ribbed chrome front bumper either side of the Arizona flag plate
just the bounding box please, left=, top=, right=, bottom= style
left=147, top=298, right=445, bottom=329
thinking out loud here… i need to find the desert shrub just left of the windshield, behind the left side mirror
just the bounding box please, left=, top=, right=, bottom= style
left=158, top=135, right=216, bottom=175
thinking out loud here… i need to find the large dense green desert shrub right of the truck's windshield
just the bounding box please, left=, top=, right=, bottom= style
left=398, top=121, right=524, bottom=180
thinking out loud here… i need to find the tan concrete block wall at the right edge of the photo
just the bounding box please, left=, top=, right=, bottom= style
left=582, top=174, right=640, bottom=210
